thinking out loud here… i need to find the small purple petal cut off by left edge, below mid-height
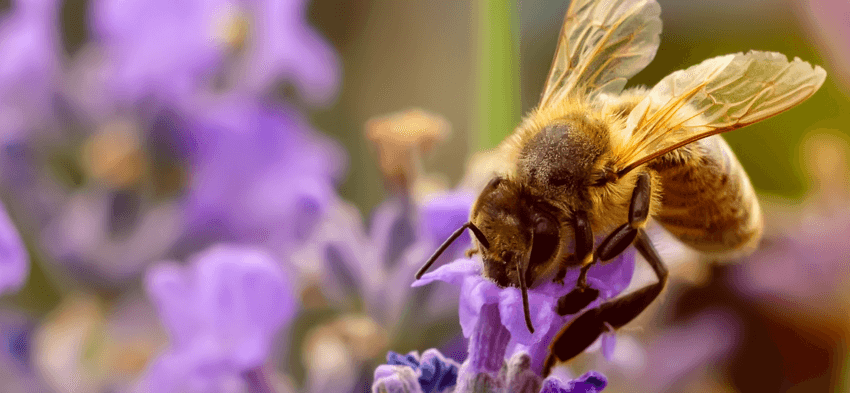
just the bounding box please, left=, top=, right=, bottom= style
left=0, top=199, right=30, bottom=295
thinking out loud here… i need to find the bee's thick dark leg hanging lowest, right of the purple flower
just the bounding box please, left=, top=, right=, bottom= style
left=543, top=229, right=667, bottom=375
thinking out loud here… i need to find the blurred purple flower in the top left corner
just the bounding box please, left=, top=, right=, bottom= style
left=0, top=0, right=61, bottom=141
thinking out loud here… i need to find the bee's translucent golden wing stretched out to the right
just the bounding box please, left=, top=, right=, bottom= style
left=614, top=51, right=826, bottom=173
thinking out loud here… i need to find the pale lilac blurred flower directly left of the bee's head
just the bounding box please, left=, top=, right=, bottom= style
left=293, top=191, right=472, bottom=327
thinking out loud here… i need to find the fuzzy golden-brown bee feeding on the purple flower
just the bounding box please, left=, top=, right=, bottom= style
left=417, top=0, right=826, bottom=374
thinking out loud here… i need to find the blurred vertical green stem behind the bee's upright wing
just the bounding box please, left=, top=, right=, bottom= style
left=472, top=0, right=520, bottom=151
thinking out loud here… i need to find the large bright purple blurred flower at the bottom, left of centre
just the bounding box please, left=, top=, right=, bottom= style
left=132, top=246, right=296, bottom=392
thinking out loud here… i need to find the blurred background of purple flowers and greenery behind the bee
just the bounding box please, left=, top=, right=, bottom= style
left=0, top=0, right=850, bottom=392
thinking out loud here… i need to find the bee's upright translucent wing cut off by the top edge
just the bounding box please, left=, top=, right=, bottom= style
left=540, top=0, right=661, bottom=107
